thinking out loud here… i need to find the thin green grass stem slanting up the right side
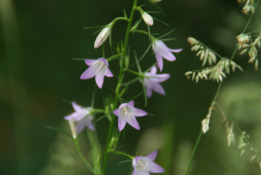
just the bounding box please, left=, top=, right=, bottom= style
left=185, top=0, right=260, bottom=175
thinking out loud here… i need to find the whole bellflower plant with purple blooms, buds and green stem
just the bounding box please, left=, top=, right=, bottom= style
left=61, top=0, right=182, bottom=175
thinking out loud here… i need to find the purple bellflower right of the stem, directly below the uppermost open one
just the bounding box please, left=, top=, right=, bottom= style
left=143, top=66, right=170, bottom=98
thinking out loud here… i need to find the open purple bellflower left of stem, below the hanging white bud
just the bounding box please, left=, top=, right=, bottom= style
left=80, top=58, right=113, bottom=88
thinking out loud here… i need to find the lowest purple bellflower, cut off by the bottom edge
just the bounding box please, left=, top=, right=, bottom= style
left=132, top=151, right=164, bottom=175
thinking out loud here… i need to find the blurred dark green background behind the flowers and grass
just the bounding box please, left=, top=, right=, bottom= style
left=0, top=0, right=261, bottom=175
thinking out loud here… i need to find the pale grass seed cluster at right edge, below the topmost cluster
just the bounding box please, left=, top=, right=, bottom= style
left=237, top=33, right=261, bottom=70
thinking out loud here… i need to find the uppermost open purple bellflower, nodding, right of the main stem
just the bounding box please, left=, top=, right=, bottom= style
left=152, top=39, right=182, bottom=71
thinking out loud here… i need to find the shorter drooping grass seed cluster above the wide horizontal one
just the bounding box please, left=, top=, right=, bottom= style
left=188, top=37, right=217, bottom=66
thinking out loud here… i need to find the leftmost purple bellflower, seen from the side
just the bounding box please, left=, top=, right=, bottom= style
left=64, top=101, right=94, bottom=134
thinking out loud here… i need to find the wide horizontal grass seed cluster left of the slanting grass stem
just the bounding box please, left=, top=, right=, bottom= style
left=185, top=58, right=243, bottom=83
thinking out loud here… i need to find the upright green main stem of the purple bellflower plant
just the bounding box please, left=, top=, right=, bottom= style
left=102, top=0, right=138, bottom=175
